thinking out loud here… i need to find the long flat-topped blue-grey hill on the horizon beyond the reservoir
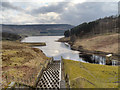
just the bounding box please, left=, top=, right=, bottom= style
left=0, top=24, right=74, bottom=36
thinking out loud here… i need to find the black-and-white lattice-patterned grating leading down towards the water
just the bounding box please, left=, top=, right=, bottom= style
left=37, top=61, right=60, bottom=89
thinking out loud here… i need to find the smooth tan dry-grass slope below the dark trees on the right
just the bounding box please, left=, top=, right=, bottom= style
left=74, top=34, right=118, bottom=53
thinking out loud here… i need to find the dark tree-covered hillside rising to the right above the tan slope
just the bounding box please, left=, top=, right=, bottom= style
left=64, top=16, right=120, bottom=39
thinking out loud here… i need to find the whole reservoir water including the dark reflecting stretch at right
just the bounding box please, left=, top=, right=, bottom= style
left=21, top=36, right=117, bottom=65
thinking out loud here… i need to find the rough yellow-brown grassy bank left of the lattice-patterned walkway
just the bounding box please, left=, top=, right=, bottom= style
left=2, top=41, right=50, bottom=87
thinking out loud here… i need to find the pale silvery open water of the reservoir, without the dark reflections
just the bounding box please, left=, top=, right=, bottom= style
left=22, top=36, right=84, bottom=62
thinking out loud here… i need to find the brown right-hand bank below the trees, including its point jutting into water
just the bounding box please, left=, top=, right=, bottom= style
left=58, top=34, right=118, bottom=54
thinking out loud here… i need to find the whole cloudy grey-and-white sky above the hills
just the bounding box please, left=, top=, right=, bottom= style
left=0, top=0, right=119, bottom=25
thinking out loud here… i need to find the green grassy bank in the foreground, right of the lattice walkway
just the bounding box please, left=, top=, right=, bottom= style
left=63, top=59, right=118, bottom=88
